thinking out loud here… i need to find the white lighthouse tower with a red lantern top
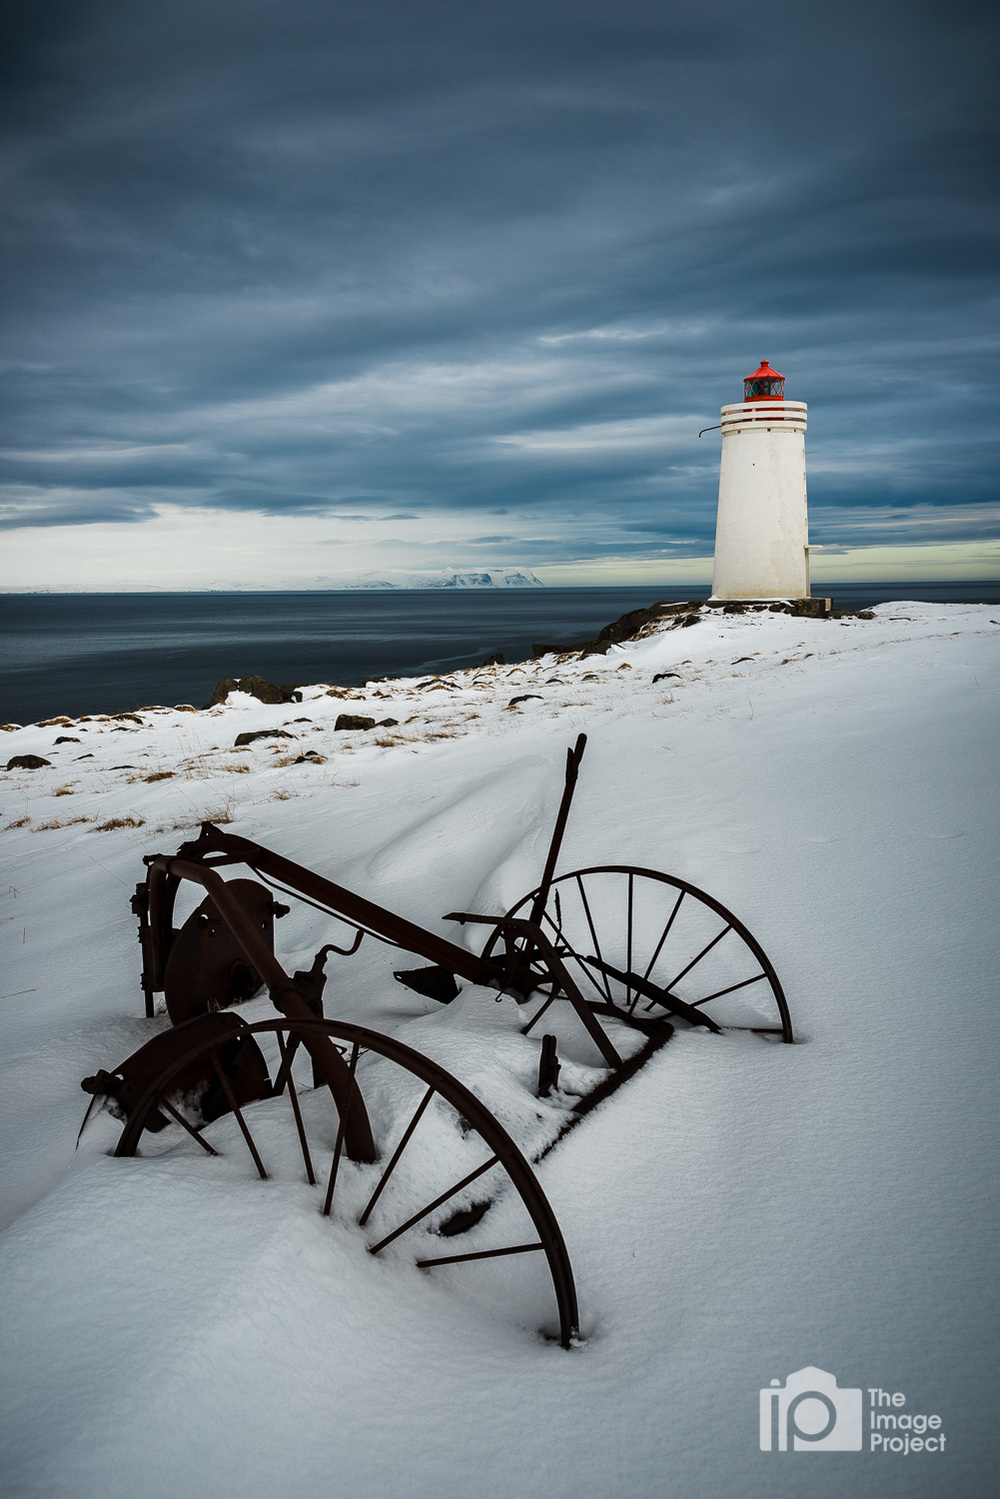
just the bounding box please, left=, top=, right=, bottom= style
left=712, top=360, right=810, bottom=600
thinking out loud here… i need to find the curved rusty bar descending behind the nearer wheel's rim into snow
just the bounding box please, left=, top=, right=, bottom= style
left=150, top=854, right=378, bottom=1162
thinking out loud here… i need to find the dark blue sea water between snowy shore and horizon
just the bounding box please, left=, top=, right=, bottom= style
left=0, top=582, right=1000, bottom=724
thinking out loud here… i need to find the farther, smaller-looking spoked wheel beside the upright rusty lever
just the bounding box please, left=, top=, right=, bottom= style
left=484, top=865, right=793, bottom=1042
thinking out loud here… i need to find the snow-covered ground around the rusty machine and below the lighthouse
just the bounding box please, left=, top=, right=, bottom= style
left=0, top=603, right=1000, bottom=1499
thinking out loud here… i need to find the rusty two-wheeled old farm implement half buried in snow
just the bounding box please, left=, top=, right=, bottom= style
left=82, top=735, right=792, bottom=1348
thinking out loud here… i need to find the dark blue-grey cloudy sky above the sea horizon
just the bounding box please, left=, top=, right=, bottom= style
left=0, top=0, right=1000, bottom=588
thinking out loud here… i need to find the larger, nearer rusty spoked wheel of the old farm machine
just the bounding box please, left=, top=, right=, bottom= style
left=115, top=1019, right=579, bottom=1348
